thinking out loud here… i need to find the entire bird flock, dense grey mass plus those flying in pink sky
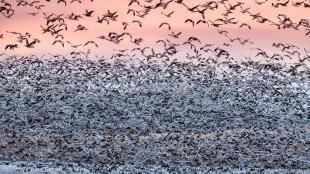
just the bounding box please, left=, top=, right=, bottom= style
left=0, top=0, right=310, bottom=173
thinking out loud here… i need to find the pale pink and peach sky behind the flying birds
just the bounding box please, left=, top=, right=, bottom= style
left=0, top=0, right=310, bottom=61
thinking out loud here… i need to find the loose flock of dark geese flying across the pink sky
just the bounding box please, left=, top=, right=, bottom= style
left=0, top=0, right=310, bottom=57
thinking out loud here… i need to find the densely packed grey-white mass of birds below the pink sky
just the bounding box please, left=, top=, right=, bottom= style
left=0, top=51, right=310, bottom=173
